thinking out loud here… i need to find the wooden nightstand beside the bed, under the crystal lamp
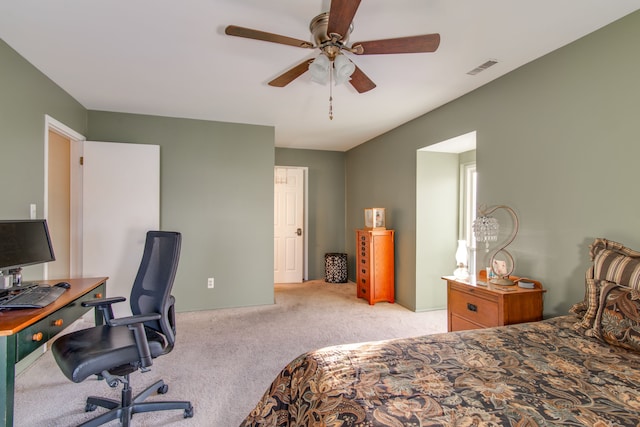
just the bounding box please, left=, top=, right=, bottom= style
left=443, top=276, right=546, bottom=332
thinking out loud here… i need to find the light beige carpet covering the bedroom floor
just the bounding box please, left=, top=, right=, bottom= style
left=14, top=280, right=447, bottom=427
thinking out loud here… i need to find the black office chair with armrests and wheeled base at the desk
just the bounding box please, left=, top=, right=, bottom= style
left=51, top=231, right=193, bottom=426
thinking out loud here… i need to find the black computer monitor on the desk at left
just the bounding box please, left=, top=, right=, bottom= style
left=0, top=219, right=56, bottom=270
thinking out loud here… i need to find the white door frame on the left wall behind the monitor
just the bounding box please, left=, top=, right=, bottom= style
left=43, top=114, right=86, bottom=279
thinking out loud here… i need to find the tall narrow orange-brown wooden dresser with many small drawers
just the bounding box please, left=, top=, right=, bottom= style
left=356, top=228, right=395, bottom=304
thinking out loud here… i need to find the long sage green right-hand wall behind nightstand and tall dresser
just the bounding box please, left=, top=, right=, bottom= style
left=347, top=12, right=640, bottom=315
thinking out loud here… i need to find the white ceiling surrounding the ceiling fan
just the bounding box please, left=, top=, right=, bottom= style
left=0, top=0, right=640, bottom=151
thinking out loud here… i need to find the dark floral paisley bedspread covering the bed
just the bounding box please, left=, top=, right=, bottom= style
left=241, top=316, right=640, bottom=427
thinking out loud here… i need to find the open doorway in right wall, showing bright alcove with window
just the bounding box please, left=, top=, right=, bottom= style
left=416, top=131, right=476, bottom=311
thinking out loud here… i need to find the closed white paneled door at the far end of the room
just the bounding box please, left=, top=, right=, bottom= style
left=273, top=167, right=305, bottom=283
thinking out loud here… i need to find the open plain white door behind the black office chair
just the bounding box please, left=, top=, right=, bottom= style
left=82, top=141, right=160, bottom=316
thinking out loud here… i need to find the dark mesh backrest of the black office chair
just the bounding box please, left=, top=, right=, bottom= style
left=130, top=231, right=182, bottom=352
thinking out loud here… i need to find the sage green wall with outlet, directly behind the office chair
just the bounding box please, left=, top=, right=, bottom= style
left=88, top=111, right=274, bottom=311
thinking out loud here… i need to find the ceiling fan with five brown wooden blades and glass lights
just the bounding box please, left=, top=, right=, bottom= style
left=225, top=0, right=440, bottom=93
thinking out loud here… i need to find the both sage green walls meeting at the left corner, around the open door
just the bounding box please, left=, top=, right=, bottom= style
left=0, top=40, right=274, bottom=311
